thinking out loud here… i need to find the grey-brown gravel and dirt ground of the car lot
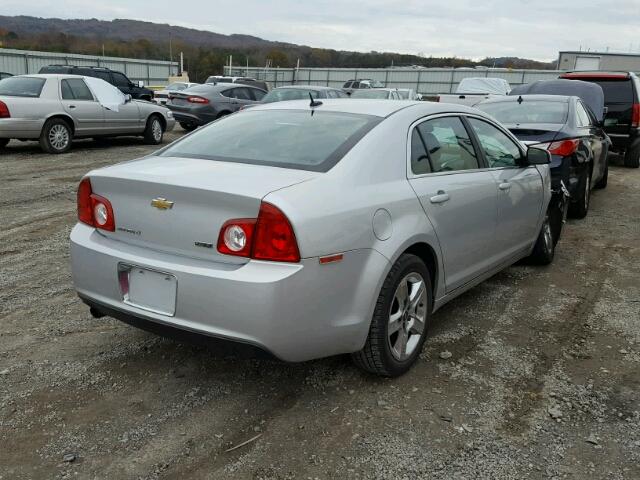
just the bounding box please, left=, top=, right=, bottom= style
left=0, top=128, right=640, bottom=480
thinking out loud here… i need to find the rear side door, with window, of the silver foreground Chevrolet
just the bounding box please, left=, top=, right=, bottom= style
left=409, top=115, right=497, bottom=292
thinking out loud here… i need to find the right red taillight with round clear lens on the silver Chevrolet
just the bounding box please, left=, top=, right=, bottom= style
left=218, top=202, right=300, bottom=263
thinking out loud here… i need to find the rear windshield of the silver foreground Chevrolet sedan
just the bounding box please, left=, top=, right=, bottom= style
left=159, top=110, right=382, bottom=172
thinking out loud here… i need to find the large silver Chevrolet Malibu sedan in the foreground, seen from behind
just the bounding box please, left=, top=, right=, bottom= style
left=71, top=99, right=554, bottom=376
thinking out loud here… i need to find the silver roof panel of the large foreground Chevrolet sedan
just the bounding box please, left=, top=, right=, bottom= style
left=247, top=98, right=480, bottom=117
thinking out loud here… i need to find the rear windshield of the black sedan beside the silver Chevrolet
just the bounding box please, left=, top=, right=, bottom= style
left=476, top=100, right=568, bottom=124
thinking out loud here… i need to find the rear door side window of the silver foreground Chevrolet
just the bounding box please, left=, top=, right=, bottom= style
left=412, top=117, right=479, bottom=174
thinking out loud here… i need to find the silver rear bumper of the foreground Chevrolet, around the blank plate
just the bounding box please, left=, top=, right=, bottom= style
left=71, top=224, right=389, bottom=362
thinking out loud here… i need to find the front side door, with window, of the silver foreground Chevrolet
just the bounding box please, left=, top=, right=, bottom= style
left=466, top=116, right=544, bottom=263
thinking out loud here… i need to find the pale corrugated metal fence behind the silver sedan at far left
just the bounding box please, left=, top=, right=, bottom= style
left=0, top=48, right=178, bottom=85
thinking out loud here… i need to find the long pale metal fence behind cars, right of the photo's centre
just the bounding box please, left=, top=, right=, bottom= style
left=225, top=66, right=562, bottom=95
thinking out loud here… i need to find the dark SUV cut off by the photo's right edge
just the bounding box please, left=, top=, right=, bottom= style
left=561, top=72, right=640, bottom=168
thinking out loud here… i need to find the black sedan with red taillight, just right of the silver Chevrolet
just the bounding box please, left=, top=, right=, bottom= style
left=476, top=95, right=610, bottom=218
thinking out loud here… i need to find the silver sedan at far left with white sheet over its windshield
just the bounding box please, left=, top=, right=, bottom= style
left=0, top=74, right=175, bottom=153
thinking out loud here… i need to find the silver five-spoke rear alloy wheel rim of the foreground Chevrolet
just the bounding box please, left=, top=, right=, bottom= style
left=387, top=272, right=427, bottom=361
